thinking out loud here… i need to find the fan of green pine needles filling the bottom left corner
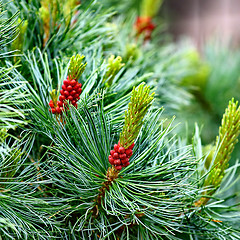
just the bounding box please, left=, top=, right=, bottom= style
left=0, top=133, right=57, bottom=239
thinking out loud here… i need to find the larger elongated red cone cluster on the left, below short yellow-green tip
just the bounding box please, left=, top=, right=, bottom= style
left=49, top=77, right=82, bottom=114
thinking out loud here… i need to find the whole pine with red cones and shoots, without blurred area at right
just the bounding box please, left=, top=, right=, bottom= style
left=0, top=0, right=240, bottom=240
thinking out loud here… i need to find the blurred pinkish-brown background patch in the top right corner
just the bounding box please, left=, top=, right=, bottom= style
left=161, top=0, right=240, bottom=48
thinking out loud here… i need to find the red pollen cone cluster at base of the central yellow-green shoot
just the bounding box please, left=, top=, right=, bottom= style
left=108, top=142, right=134, bottom=171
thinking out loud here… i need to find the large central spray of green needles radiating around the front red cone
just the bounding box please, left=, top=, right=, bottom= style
left=46, top=101, right=202, bottom=238
